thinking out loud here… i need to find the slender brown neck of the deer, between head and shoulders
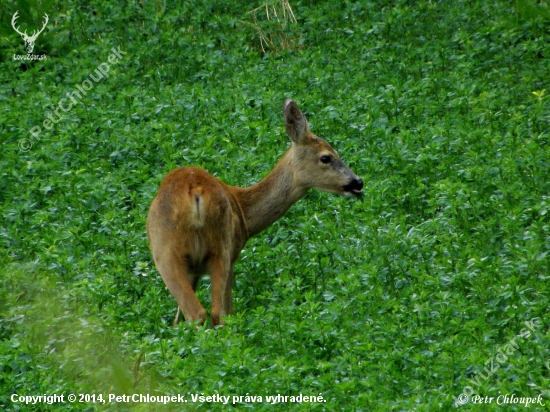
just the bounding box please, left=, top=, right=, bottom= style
left=235, top=149, right=308, bottom=237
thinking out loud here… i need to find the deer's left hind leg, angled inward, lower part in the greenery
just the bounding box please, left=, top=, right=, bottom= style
left=156, top=253, right=206, bottom=325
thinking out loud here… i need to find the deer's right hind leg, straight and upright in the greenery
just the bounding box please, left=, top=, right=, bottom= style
left=208, top=256, right=233, bottom=327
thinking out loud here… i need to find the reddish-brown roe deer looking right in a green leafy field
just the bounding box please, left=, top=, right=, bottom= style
left=147, top=99, right=363, bottom=326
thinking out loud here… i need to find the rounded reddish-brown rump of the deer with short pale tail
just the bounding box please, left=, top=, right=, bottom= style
left=148, top=166, right=246, bottom=276
